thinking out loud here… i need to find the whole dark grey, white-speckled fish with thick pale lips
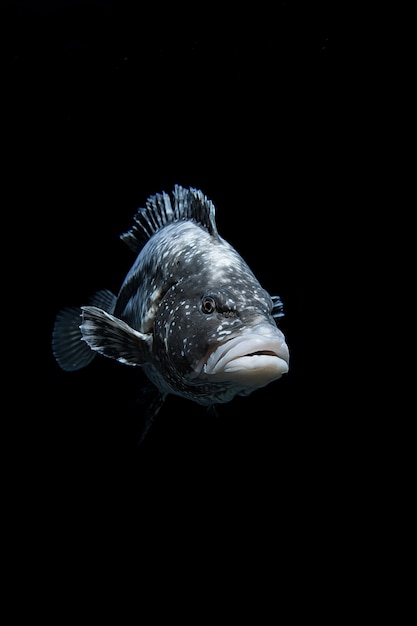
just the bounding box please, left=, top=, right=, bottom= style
left=52, top=185, right=289, bottom=439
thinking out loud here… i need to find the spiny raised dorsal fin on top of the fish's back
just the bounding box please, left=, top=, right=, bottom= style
left=120, top=185, right=219, bottom=254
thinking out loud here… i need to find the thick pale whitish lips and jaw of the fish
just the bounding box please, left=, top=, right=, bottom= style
left=200, top=325, right=289, bottom=389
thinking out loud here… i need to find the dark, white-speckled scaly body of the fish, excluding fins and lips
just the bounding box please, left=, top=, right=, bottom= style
left=114, top=221, right=275, bottom=403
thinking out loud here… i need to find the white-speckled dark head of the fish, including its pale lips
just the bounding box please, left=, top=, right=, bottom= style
left=154, top=284, right=289, bottom=399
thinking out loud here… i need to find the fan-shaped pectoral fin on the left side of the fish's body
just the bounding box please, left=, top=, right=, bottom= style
left=80, top=306, right=152, bottom=366
